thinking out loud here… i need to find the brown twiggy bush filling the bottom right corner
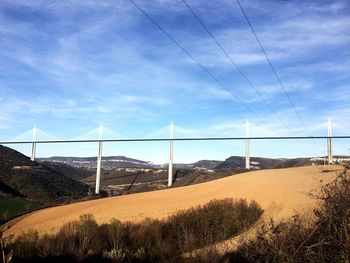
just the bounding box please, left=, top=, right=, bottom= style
left=227, top=169, right=350, bottom=262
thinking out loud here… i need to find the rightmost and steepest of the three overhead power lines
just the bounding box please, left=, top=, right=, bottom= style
left=236, top=0, right=310, bottom=136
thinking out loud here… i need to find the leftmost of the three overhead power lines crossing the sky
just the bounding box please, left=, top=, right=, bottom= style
left=129, top=0, right=284, bottom=134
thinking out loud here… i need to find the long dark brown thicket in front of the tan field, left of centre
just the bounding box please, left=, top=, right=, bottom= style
left=10, top=199, right=262, bottom=262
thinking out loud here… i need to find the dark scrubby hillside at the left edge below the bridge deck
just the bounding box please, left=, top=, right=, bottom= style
left=0, top=145, right=89, bottom=204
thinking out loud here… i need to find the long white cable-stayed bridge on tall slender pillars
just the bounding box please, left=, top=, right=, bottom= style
left=0, top=120, right=350, bottom=194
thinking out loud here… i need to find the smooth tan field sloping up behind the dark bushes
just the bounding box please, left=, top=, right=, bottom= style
left=6, top=166, right=341, bottom=235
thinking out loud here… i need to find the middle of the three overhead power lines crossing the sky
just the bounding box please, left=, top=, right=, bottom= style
left=182, top=0, right=291, bottom=135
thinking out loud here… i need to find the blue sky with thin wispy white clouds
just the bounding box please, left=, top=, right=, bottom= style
left=0, top=0, right=350, bottom=162
